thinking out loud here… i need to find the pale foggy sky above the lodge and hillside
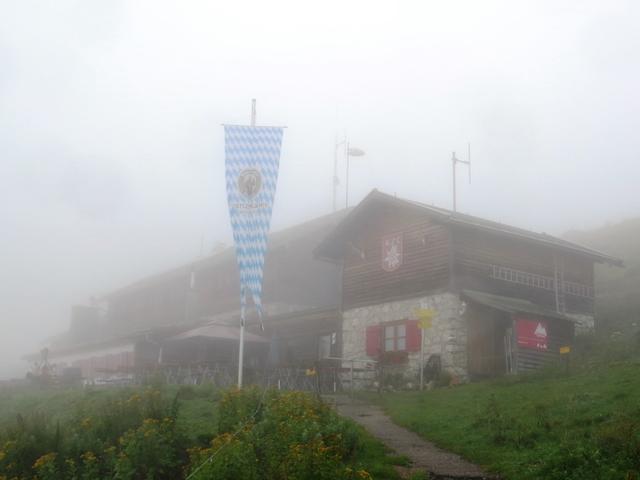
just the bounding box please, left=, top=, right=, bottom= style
left=0, top=0, right=640, bottom=378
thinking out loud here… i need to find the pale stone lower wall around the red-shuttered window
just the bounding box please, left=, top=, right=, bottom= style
left=342, top=293, right=467, bottom=386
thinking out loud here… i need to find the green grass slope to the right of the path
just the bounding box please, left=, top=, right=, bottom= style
left=367, top=362, right=640, bottom=480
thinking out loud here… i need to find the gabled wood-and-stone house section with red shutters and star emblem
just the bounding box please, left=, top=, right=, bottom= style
left=315, top=190, right=621, bottom=384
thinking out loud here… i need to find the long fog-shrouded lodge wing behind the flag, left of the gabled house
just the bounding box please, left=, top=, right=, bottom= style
left=25, top=211, right=346, bottom=384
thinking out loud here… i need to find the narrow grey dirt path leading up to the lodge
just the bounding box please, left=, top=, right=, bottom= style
left=329, top=397, right=496, bottom=480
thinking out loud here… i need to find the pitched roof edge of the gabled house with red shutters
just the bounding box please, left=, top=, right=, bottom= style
left=314, top=189, right=623, bottom=266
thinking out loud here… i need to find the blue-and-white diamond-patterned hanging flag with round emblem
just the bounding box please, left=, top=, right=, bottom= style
left=224, top=125, right=283, bottom=328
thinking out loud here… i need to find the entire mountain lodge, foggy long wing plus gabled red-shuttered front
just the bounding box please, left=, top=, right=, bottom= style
left=31, top=190, right=621, bottom=386
